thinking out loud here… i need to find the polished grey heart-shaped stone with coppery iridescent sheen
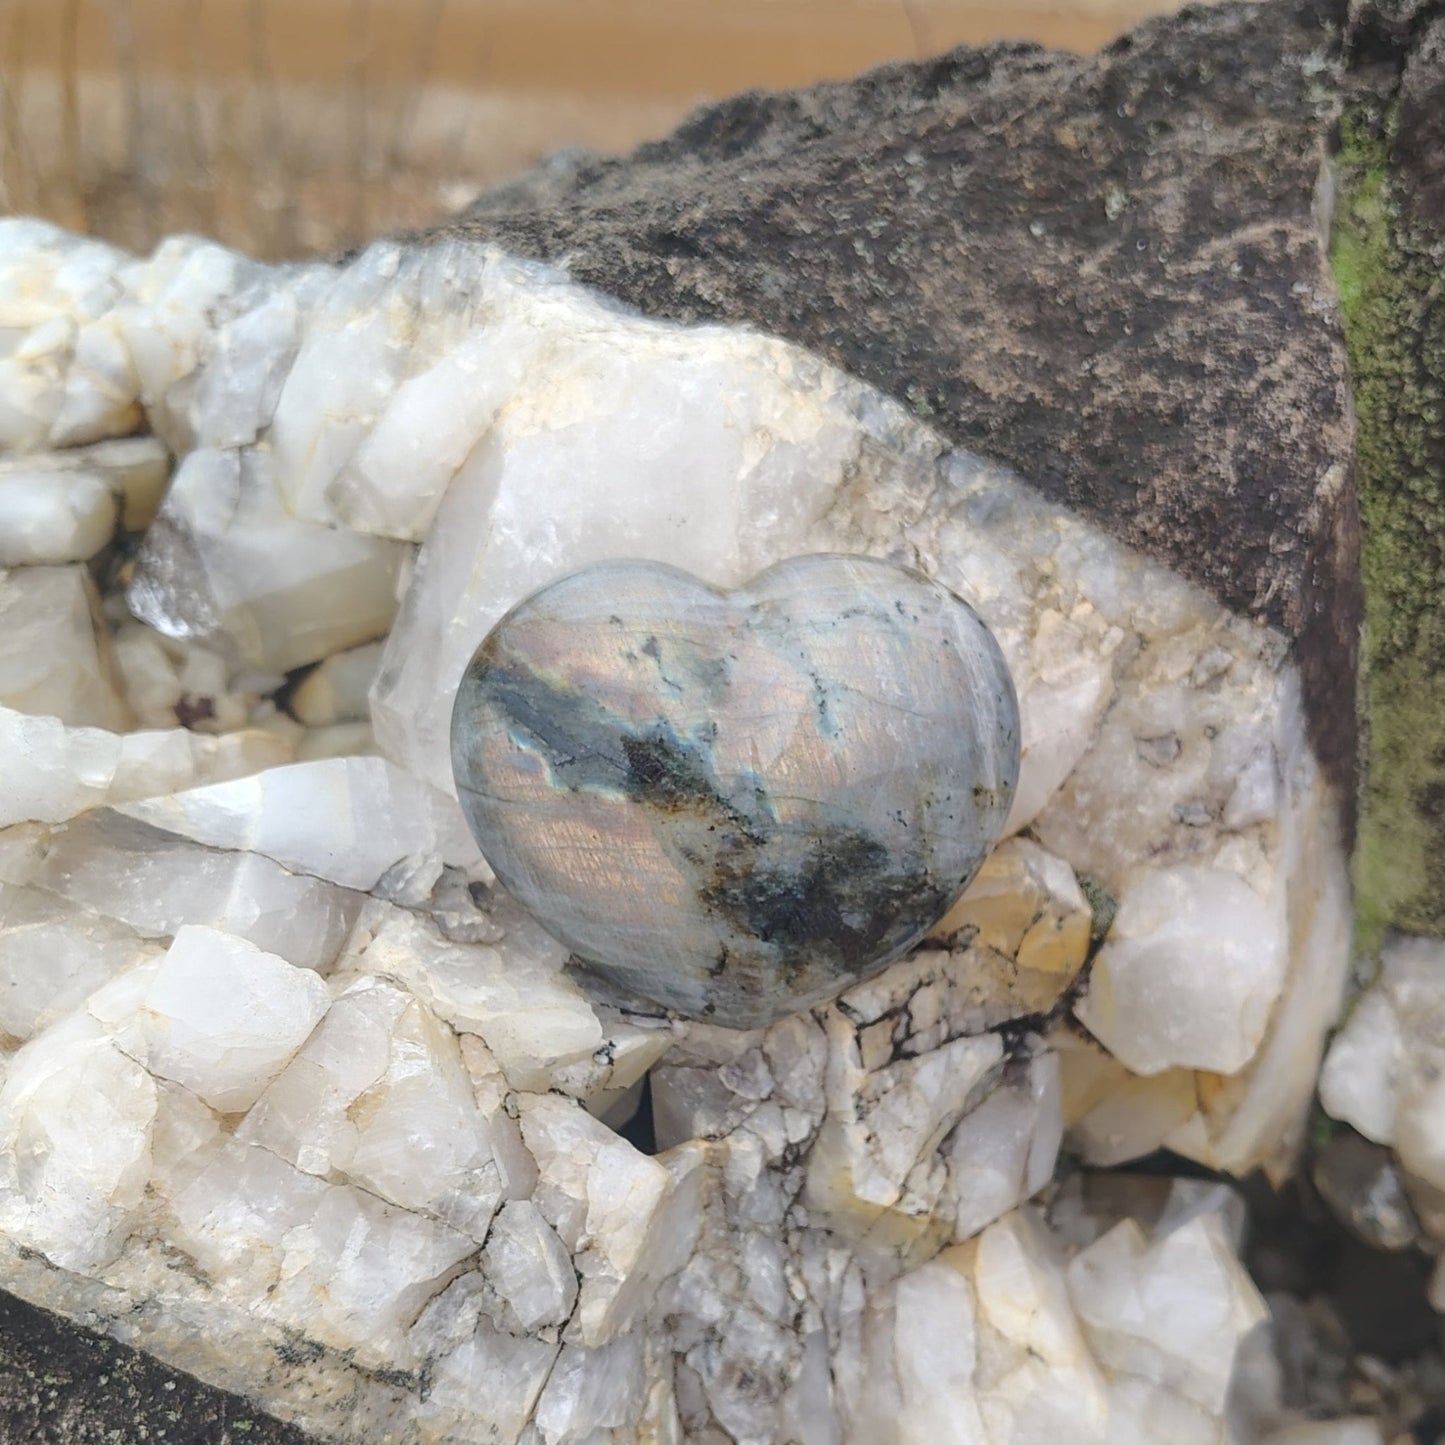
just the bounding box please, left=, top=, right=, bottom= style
left=452, top=555, right=1019, bottom=1029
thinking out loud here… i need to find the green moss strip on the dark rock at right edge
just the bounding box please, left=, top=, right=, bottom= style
left=1331, top=104, right=1445, bottom=951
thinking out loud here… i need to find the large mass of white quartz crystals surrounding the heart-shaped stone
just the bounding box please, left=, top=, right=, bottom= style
left=0, top=221, right=1364, bottom=1445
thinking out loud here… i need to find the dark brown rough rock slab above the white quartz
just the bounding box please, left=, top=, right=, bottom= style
left=441, top=0, right=1360, bottom=814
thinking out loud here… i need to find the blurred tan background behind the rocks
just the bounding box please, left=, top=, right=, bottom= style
left=0, top=0, right=1219, bottom=257
